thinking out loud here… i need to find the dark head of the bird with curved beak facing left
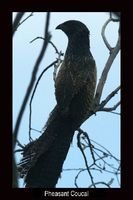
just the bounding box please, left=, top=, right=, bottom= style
left=56, top=20, right=89, bottom=38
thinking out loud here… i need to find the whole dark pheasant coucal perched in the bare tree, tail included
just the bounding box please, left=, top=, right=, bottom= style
left=18, top=20, right=96, bottom=188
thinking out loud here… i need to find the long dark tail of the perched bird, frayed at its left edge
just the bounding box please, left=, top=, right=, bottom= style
left=19, top=106, right=74, bottom=188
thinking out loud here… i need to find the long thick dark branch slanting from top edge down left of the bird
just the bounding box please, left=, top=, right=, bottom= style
left=13, top=12, right=51, bottom=147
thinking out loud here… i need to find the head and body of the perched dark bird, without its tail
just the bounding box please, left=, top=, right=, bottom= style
left=55, top=20, right=96, bottom=128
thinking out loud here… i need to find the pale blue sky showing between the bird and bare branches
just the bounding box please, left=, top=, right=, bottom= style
left=13, top=12, right=121, bottom=187
